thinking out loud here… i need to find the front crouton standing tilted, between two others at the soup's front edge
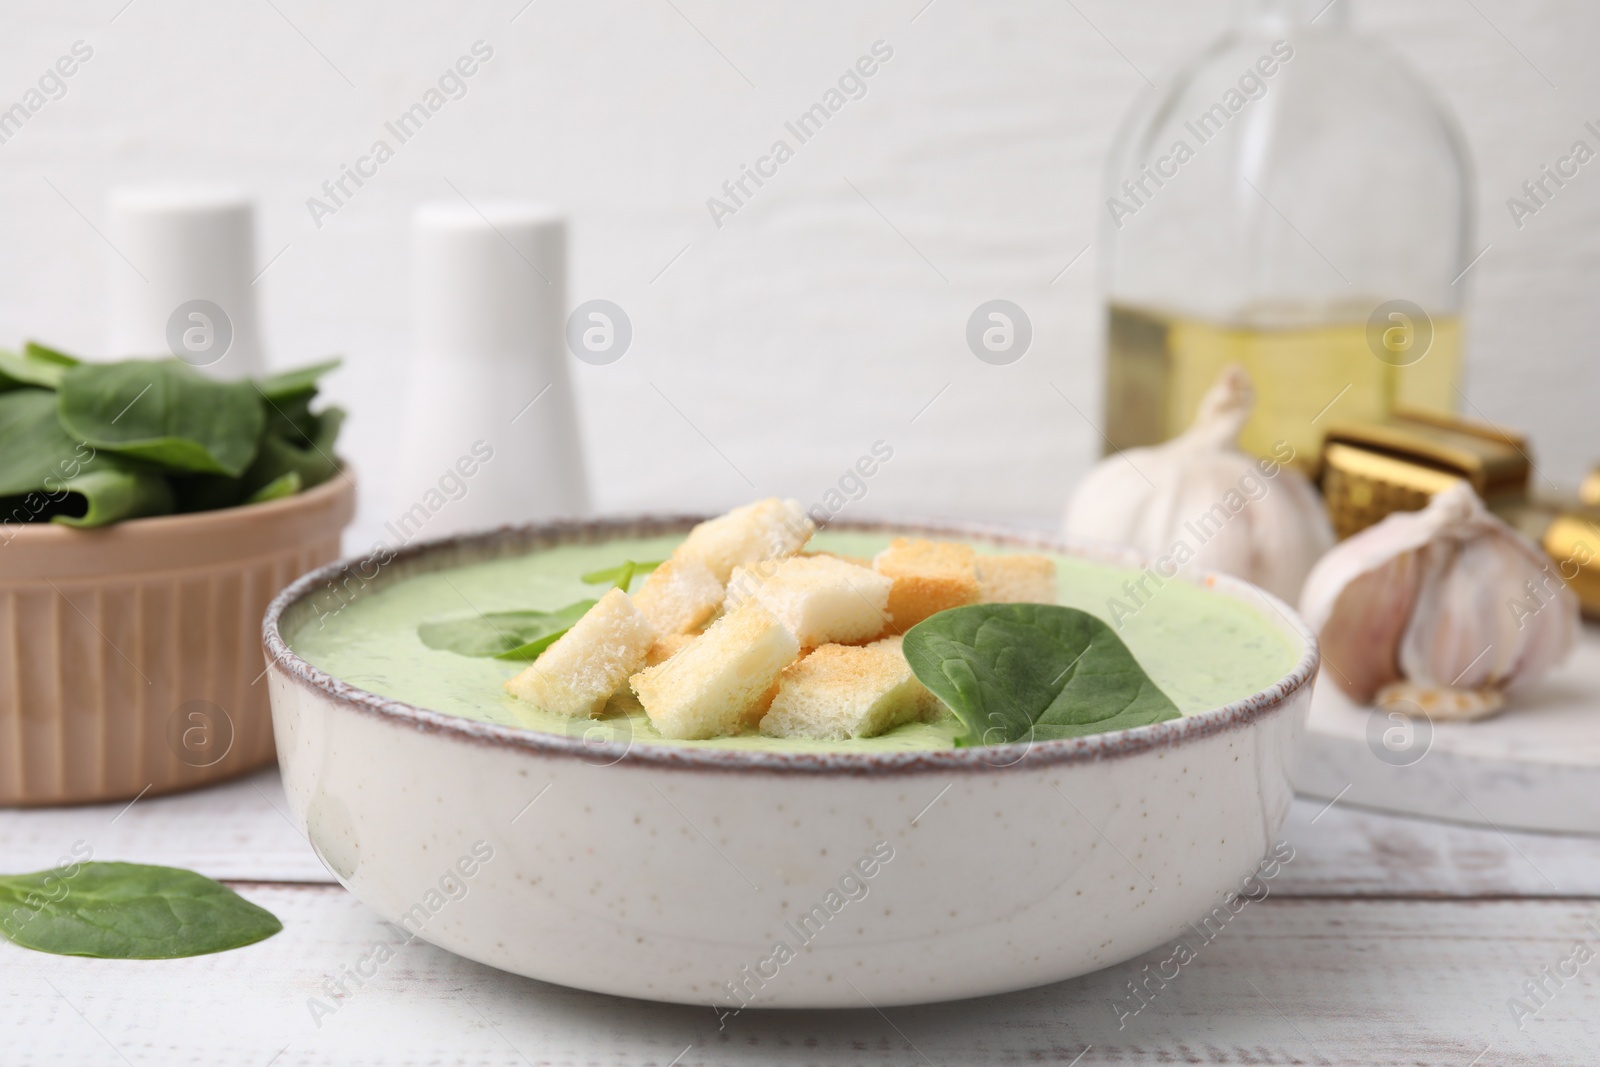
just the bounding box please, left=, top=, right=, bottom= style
left=632, top=600, right=800, bottom=741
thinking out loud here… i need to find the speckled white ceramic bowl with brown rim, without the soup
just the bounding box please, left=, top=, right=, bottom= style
left=264, top=518, right=1317, bottom=1011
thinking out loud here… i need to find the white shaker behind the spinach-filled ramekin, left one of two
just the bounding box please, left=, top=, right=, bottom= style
left=107, top=187, right=266, bottom=379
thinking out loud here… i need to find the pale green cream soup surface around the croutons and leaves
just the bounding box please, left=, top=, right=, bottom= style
left=285, top=533, right=1299, bottom=752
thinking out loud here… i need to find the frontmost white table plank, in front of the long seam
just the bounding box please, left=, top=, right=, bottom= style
left=0, top=885, right=1600, bottom=1067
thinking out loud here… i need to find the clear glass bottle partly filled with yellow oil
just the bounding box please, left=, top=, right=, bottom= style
left=1099, top=0, right=1477, bottom=470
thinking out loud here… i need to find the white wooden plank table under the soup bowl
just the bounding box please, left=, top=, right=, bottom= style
left=0, top=771, right=1600, bottom=1067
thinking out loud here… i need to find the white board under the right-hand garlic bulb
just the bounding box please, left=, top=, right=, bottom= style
left=1296, top=625, right=1600, bottom=833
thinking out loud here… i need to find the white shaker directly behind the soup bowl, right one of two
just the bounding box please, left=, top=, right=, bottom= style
left=386, top=202, right=589, bottom=542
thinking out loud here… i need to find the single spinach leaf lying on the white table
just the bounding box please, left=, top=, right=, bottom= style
left=0, top=862, right=283, bottom=960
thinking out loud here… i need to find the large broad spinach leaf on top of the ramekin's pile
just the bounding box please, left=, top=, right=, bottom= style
left=56, top=360, right=266, bottom=475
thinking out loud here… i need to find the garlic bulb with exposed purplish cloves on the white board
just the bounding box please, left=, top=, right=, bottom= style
left=1301, top=482, right=1579, bottom=720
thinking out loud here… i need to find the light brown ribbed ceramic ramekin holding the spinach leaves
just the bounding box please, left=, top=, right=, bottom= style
left=0, top=475, right=355, bottom=806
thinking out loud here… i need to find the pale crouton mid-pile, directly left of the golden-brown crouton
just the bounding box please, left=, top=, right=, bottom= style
left=728, top=555, right=894, bottom=648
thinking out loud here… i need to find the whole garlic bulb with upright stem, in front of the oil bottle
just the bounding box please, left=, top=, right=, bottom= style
left=1062, top=365, right=1333, bottom=603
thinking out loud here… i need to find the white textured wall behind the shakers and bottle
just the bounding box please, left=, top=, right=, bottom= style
left=0, top=0, right=1600, bottom=544
